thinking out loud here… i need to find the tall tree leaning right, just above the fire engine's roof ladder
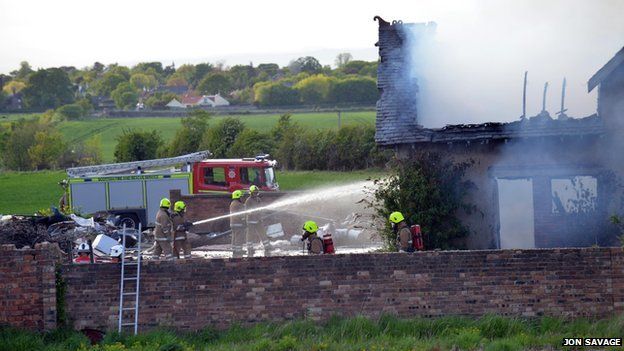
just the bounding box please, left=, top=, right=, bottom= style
left=167, top=110, right=210, bottom=156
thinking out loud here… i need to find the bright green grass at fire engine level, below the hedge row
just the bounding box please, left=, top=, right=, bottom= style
left=0, top=170, right=383, bottom=214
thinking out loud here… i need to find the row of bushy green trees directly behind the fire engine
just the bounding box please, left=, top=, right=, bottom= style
left=115, top=111, right=391, bottom=171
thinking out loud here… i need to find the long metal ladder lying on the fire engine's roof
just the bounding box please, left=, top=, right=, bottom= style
left=67, top=150, right=211, bottom=178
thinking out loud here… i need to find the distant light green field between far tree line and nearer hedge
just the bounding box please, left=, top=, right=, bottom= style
left=59, top=111, right=375, bottom=162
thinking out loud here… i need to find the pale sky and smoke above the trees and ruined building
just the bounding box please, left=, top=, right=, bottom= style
left=0, top=0, right=624, bottom=124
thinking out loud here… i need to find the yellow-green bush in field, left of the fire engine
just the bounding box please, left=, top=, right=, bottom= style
left=28, top=131, right=66, bottom=170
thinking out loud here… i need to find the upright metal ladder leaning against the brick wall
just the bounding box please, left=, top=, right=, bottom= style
left=118, top=223, right=141, bottom=335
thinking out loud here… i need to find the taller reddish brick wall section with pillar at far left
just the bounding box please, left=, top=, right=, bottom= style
left=0, top=243, right=60, bottom=330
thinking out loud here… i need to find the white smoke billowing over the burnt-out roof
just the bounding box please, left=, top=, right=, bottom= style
left=403, top=0, right=624, bottom=127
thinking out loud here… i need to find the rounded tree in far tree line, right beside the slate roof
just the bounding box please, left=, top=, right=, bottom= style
left=328, top=77, right=379, bottom=104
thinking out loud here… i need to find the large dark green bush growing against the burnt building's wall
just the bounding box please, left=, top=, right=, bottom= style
left=370, top=152, right=476, bottom=250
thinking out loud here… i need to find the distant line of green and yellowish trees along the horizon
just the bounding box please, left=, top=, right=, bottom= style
left=0, top=53, right=378, bottom=113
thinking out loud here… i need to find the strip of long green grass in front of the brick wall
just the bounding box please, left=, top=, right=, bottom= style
left=0, top=316, right=624, bottom=351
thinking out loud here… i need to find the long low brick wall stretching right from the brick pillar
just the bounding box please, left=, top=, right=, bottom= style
left=62, top=248, right=624, bottom=330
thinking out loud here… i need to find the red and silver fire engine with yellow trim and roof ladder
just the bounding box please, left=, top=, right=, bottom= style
left=65, top=151, right=279, bottom=227
